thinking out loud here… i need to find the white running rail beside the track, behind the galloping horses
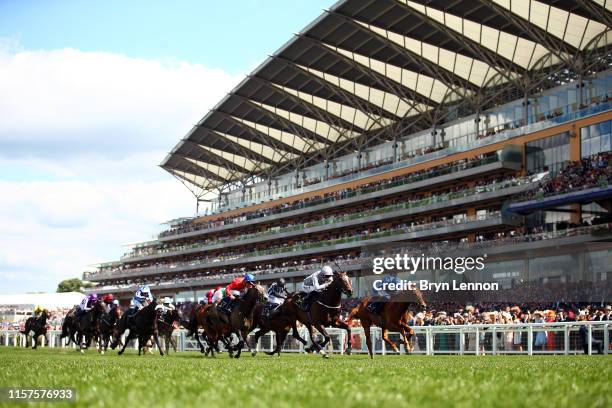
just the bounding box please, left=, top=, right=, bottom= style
left=0, top=321, right=612, bottom=355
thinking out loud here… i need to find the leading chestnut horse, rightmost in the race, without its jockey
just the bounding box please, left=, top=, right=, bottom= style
left=348, top=289, right=426, bottom=358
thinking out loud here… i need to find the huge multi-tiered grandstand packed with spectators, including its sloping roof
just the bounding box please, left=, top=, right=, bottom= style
left=83, top=0, right=612, bottom=300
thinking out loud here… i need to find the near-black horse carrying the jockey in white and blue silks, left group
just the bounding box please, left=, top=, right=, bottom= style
left=111, top=301, right=164, bottom=356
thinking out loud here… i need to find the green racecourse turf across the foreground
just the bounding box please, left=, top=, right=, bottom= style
left=0, top=347, right=612, bottom=408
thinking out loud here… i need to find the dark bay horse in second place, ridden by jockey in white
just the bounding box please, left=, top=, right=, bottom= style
left=284, top=271, right=353, bottom=358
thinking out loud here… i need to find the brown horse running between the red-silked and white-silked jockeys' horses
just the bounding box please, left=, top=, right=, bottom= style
left=251, top=302, right=307, bottom=357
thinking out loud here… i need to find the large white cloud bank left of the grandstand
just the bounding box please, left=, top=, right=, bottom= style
left=0, top=42, right=240, bottom=293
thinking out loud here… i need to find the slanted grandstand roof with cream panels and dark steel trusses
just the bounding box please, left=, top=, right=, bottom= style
left=161, top=0, right=612, bottom=191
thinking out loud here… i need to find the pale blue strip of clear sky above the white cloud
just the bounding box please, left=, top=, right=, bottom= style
left=0, top=0, right=333, bottom=73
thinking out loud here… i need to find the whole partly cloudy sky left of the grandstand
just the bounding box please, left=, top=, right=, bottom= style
left=0, top=0, right=333, bottom=294
